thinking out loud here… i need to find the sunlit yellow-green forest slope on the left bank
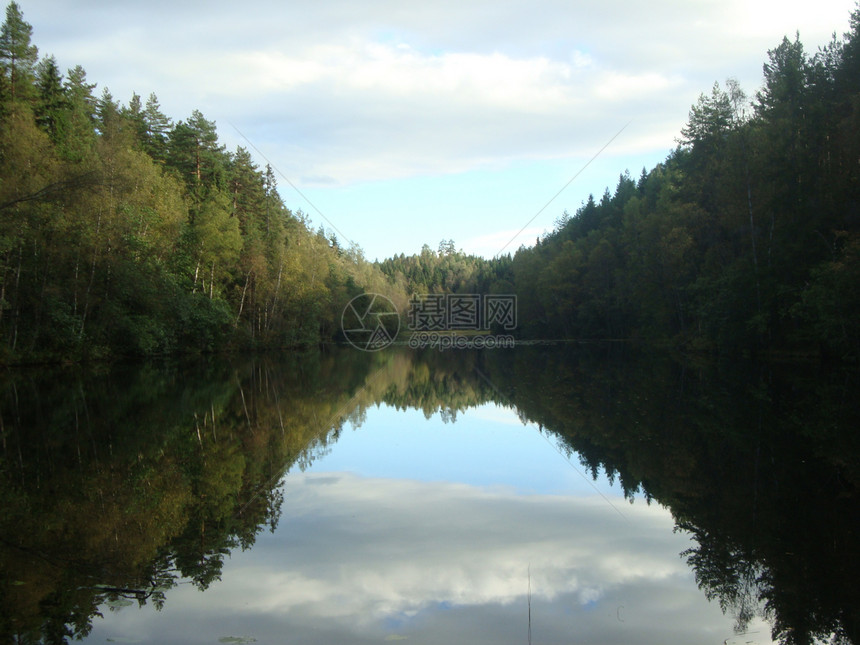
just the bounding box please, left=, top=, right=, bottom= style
left=0, top=2, right=397, bottom=362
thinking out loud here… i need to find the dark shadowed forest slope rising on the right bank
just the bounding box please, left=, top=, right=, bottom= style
left=513, top=9, right=860, bottom=358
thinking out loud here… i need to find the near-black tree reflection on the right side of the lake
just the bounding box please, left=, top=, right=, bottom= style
left=488, top=348, right=860, bottom=643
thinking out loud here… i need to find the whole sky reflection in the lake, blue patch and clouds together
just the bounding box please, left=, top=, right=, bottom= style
left=84, top=404, right=771, bottom=645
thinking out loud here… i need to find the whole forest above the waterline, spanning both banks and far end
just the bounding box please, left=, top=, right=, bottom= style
left=0, top=2, right=860, bottom=364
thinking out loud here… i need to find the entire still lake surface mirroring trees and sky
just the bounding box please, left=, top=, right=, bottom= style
left=0, top=346, right=860, bottom=644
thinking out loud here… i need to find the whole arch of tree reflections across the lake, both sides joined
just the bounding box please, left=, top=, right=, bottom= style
left=0, top=347, right=860, bottom=643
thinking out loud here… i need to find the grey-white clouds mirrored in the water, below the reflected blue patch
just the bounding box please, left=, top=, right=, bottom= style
left=93, top=473, right=769, bottom=645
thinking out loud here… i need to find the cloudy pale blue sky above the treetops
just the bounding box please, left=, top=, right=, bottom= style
left=19, top=0, right=855, bottom=260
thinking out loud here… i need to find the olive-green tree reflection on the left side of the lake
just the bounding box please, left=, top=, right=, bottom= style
left=0, top=353, right=386, bottom=642
